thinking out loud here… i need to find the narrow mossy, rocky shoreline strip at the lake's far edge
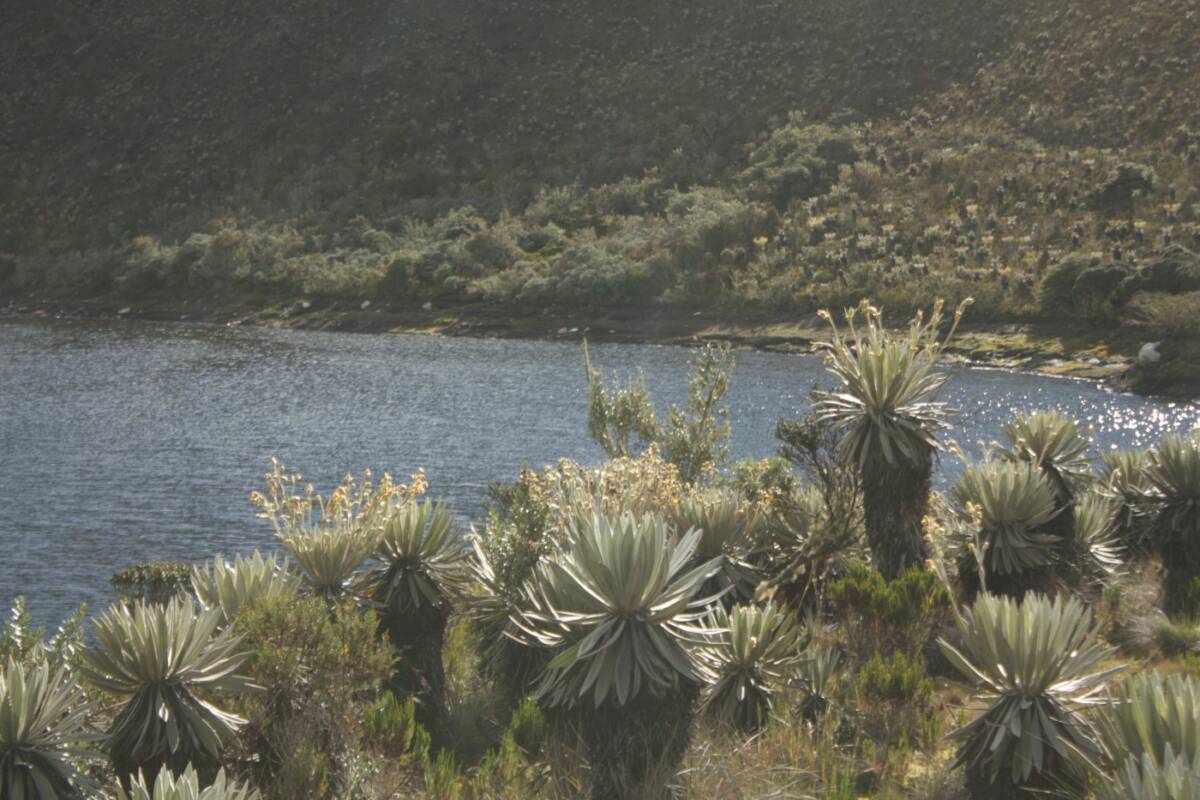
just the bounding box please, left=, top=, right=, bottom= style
left=0, top=297, right=1147, bottom=398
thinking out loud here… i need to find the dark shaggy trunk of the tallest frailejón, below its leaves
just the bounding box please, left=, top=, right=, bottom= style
left=863, top=453, right=934, bottom=581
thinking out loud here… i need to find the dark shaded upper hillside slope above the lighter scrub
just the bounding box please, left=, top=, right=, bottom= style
left=0, top=0, right=1027, bottom=252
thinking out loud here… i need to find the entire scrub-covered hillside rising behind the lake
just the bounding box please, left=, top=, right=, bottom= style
left=0, top=0, right=1200, bottom=391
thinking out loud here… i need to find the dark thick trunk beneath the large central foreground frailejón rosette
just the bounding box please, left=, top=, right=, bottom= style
left=577, top=686, right=698, bottom=800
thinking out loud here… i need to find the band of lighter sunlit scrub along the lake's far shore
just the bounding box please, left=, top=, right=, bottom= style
left=10, top=118, right=1200, bottom=320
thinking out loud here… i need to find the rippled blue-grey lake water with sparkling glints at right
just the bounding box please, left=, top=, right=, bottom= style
left=0, top=320, right=1200, bottom=624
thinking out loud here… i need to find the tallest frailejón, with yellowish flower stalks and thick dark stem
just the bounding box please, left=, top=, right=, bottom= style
left=814, top=301, right=970, bottom=581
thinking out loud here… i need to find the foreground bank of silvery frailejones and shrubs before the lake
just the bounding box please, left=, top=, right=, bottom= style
left=7, top=314, right=1200, bottom=800
